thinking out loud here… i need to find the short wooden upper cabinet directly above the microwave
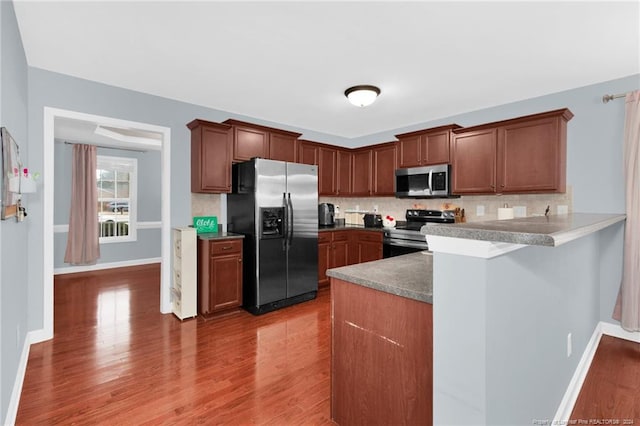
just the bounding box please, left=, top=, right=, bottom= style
left=396, top=124, right=460, bottom=168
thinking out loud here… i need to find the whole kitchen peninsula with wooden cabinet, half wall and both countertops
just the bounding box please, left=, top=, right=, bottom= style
left=328, top=213, right=625, bottom=425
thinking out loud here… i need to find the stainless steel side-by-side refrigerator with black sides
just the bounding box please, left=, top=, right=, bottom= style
left=227, top=158, right=318, bottom=315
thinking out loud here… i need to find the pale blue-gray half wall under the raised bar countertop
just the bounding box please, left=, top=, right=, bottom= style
left=433, top=223, right=624, bottom=425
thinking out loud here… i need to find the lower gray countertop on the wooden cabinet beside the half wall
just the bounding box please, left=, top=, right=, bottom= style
left=327, top=251, right=433, bottom=303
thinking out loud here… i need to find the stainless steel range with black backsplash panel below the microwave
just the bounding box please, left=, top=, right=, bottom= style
left=382, top=209, right=455, bottom=258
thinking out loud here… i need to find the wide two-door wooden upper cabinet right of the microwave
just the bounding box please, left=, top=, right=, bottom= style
left=451, top=109, right=573, bottom=194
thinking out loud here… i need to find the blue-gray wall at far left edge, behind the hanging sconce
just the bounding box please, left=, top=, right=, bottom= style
left=0, top=1, right=29, bottom=423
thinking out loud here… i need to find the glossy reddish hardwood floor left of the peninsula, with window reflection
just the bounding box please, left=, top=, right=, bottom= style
left=16, top=265, right=333, bottom=425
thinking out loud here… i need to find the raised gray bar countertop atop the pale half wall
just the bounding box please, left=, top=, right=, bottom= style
left=421, top=213, right=626, bottom=247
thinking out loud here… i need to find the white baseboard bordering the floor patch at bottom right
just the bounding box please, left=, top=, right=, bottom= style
left=552, top=321, right=640, bottom=425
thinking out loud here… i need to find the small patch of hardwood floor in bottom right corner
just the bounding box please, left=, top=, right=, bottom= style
left=571, top=335, right=640, bottom=425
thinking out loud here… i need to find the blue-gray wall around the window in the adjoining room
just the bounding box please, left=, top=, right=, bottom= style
left=53, top=142, right=162, bottom=268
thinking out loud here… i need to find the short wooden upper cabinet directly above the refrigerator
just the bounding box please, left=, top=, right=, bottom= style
left=224, top=119, right=300, bottom=162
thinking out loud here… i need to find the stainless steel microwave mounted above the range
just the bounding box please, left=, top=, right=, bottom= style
left=395, top=164, right=452, bottom=198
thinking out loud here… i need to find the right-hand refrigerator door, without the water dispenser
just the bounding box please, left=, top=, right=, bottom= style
left=287, top=163, right=318, bottom=297
